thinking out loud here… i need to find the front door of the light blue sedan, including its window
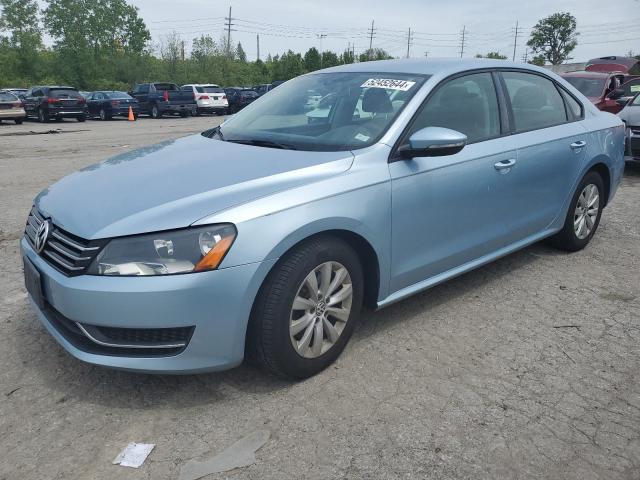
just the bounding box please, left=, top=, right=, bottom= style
left=389, top=72, right=516, bottom=291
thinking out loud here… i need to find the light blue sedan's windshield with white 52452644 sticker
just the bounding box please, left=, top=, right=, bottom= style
left=220, top=72, right=427, bottom=151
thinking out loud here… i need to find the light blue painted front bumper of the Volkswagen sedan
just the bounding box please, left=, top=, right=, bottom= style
left=21, top=238, right=275, bottom=373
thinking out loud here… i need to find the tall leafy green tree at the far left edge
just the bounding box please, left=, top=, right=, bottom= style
left=0, top=0, right=42, bottom=78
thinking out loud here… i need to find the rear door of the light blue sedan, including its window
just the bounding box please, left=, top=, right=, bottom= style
left=500, top=71, right=587, bottom=243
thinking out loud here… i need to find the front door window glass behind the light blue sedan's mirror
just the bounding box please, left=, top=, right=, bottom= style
left=407, top=73, right=500, bottom=143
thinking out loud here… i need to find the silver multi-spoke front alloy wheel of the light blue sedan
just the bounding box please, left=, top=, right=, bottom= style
left=289, top=261, right=353, bottom=358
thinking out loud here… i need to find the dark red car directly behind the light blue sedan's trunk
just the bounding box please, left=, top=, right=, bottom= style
left=561, top=72, right=625, bottom=113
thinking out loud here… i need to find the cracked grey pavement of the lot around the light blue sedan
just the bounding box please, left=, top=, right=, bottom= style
left=0, top=117, right=640, bottom=480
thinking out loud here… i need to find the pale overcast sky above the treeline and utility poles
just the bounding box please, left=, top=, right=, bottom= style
left=130, top=0, right=640, bottom=62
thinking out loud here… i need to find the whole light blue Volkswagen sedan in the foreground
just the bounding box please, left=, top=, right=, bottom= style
left=21, top=60, right=625, bottom=378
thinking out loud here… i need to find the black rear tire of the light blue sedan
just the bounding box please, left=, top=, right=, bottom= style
left=549, top=171, right=605, bottom=252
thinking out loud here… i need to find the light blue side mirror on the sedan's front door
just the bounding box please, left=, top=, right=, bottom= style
left=398, top=127, right=467, bottom=158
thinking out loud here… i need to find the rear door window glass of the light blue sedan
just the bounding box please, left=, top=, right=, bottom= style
left=502, top=72, right=567, bottom=132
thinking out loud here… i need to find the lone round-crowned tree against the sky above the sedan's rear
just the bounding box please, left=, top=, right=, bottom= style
left=527, top=13, right=579, bottom=65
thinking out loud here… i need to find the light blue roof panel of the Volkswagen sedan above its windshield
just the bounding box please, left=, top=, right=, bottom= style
left=314, top=58, right=551, bottom=75
